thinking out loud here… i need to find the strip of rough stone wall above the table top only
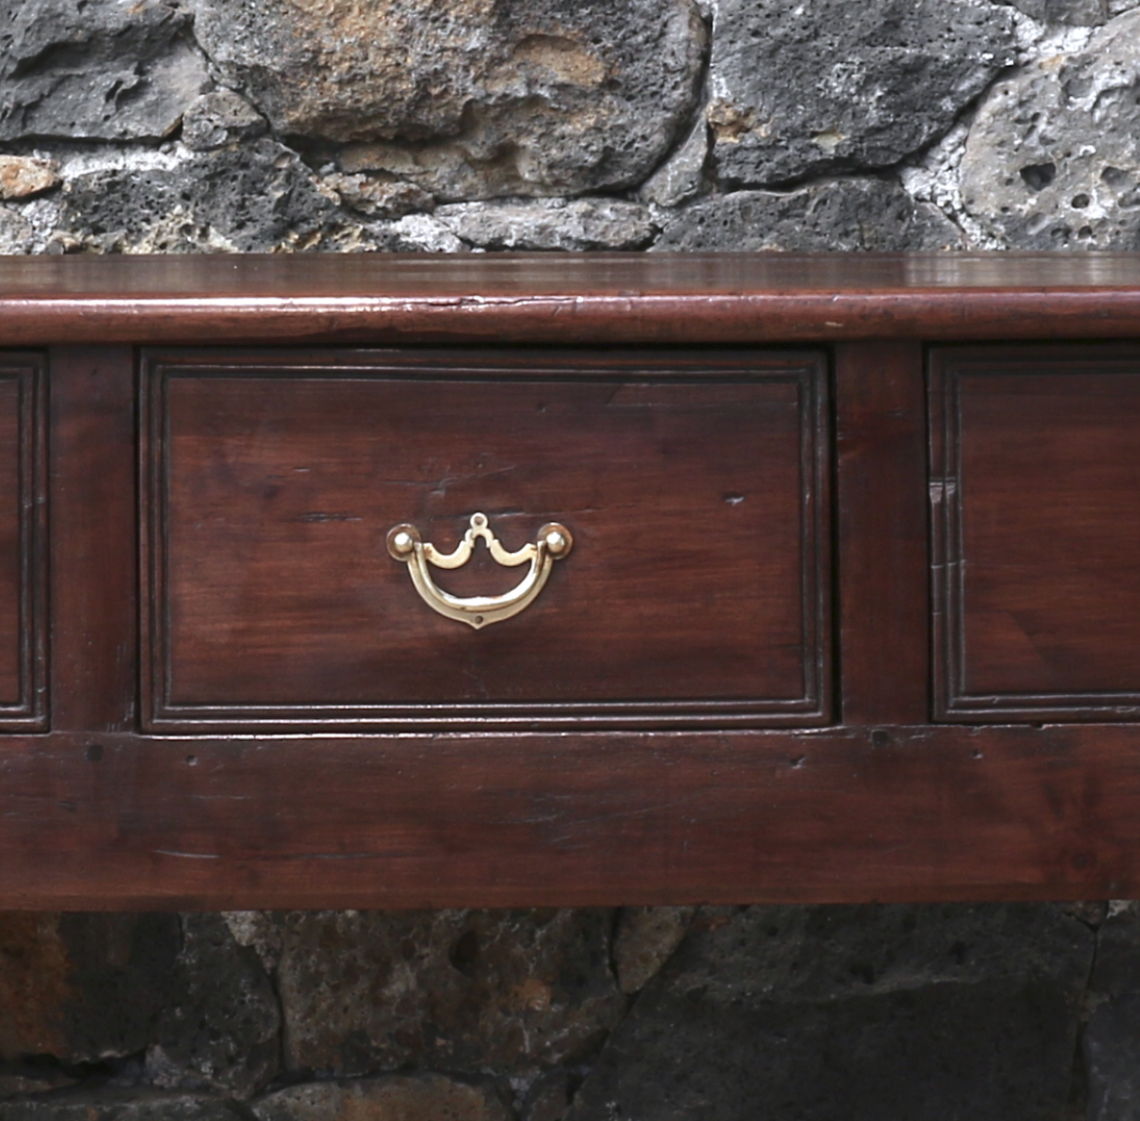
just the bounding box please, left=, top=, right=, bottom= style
left=0, top=0, right=1140, bottom=253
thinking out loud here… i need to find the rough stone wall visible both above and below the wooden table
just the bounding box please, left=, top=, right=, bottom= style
left=0, top=0, right=1140, bottom=1121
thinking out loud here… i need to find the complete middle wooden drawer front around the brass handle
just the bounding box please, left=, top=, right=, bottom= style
left=141, top=350, right=831, bottom=730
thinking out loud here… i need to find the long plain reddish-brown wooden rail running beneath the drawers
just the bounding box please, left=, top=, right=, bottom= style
left=0, top=724, right=1140, bottom=909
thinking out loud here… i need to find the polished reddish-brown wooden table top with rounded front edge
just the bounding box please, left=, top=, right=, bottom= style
left=0, top=253, right=1140, bottom=346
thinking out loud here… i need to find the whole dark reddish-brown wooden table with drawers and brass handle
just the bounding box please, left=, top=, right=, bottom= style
left=0, top=247, right=1140, bottom=909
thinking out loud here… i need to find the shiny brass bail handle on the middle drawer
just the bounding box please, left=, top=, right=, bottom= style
left=388, top=513, right=573, bottom=631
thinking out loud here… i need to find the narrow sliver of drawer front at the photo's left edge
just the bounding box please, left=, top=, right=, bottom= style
left=0, top=354, right=47, bottom=730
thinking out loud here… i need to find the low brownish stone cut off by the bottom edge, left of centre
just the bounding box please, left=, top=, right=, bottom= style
left=253, top=1074, right=511, bottom=1121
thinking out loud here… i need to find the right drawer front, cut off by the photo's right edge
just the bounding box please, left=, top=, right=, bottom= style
left=930, top=344, right=1140, bottom=721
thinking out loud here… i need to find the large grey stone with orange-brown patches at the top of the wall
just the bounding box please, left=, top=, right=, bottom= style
left=193, top=0, right=705, bottom=201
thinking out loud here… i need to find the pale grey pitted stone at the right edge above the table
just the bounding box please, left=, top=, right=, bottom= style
left=961, top=11, right=1140, bottom=250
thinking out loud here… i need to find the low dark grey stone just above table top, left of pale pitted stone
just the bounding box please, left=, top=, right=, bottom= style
left=653, top=179, right=961, bottom=252
